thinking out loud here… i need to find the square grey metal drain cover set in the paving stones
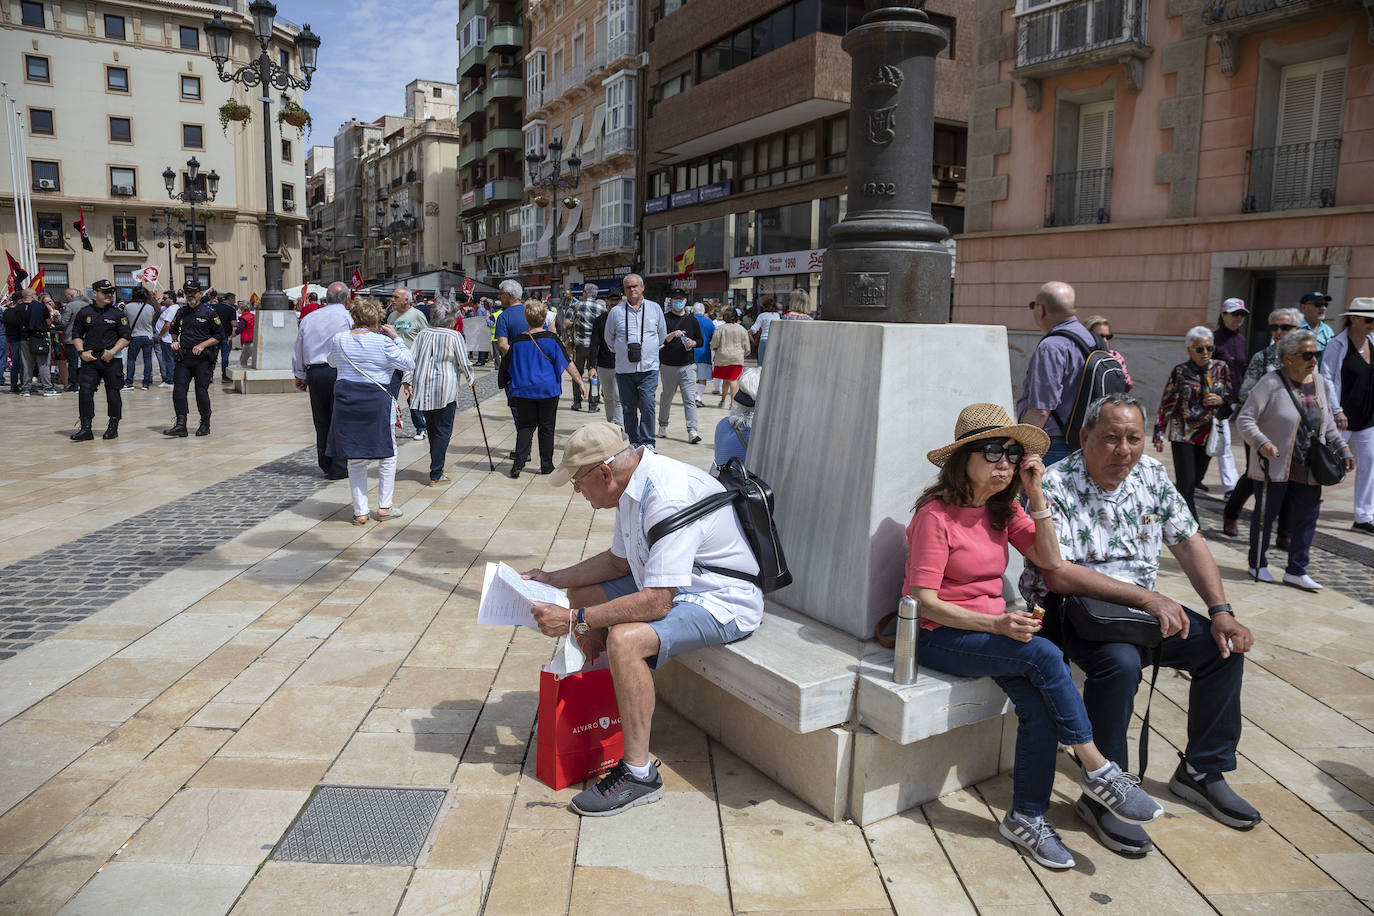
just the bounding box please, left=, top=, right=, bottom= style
left=272, top=786, right=445, bottom=865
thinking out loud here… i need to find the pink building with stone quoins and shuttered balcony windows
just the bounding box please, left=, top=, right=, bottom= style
left=955, top=0, right=1374, bottom=400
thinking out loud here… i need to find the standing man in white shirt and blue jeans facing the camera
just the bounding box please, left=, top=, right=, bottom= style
left=606, top=273, right=668, bottom=448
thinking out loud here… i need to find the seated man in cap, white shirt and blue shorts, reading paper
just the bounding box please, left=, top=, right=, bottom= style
left=525, top=423, right=764, bottom=817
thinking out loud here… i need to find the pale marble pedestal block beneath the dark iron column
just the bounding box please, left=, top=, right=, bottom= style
left=747, top=321, right=1021, bottom=639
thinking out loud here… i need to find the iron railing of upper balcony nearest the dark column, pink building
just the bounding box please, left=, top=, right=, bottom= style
left=1017, top=0, right=1147, bottom=67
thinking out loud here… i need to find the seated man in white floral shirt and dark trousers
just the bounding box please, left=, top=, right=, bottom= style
left=1021, top=394, right=1260, bottom=854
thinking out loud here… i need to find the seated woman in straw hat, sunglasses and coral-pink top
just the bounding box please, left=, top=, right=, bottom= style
left=905, top=404, right=1162, bottom=868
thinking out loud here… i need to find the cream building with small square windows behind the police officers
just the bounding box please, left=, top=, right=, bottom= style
left=0, top=0, right=309, bottom=298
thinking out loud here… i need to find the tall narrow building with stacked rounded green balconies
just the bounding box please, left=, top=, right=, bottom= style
left=455, top=0, right=525, bottom=283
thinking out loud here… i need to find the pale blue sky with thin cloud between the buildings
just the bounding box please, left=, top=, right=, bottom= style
left=287, top=0, right=459, bottom=152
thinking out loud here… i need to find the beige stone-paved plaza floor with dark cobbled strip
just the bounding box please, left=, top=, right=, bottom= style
left=0, top=370, right=1374, bottom=916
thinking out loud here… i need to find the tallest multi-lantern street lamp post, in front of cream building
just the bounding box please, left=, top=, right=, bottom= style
left=205, top=0, right=320, bottom=310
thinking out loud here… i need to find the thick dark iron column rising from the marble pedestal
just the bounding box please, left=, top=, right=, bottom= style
left=820, top=0, right=949, bottom=324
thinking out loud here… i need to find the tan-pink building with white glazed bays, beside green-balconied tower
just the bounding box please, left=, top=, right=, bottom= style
left=519, top=0, right=642, bottom=293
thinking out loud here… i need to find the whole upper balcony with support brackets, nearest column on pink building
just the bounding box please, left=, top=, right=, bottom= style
left=1013, top=0, right=1153, bottom=96
